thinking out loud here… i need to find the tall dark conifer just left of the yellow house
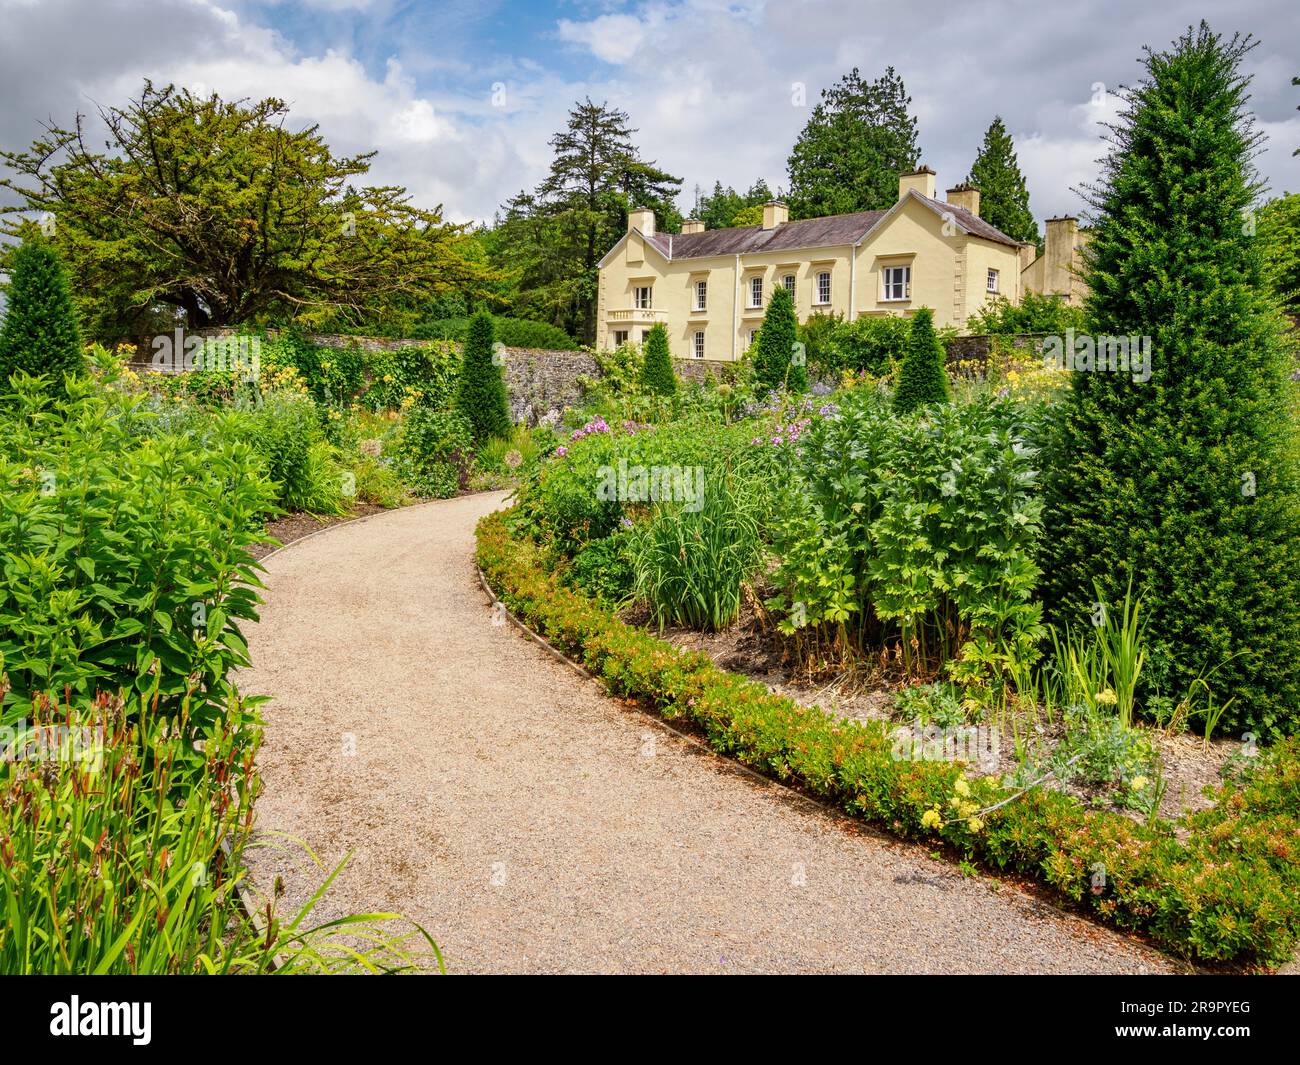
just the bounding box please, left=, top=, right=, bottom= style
left=497, top=99, right=681, bottom=343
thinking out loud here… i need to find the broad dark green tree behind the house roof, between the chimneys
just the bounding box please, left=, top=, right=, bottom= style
left=788, top=66, right=920, bottom=218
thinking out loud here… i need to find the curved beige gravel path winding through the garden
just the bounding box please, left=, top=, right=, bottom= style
left=239, top=493, right=1173, bottom=973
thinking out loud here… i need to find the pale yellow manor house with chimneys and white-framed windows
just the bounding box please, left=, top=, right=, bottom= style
left=595, top=166, right=1083, bottom=360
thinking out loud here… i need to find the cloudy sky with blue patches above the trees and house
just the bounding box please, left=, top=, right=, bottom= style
left=0, top=0, right=1300, bottom=222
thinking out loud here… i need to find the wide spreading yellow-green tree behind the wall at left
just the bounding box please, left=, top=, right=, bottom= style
left=0, top=82, right=491, bottom=337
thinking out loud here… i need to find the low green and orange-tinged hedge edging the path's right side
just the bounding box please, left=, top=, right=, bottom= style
left=477, top=511, right=1300, bottom=966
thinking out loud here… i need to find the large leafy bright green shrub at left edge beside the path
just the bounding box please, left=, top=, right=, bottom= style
left=0, top=371, right=273, bottom=715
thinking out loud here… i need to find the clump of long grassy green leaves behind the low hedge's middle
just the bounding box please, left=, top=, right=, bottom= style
left=628, top=467, right=763, bottom=632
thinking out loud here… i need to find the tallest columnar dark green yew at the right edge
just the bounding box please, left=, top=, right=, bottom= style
left=1043, top=23, right=1300, bottom=735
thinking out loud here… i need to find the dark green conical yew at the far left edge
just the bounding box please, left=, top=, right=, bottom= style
left=0, top=239, right=85, bottom=397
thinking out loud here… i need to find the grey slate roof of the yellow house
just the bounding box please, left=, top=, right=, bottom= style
left=646, top=191, right=1021, bottom=261
